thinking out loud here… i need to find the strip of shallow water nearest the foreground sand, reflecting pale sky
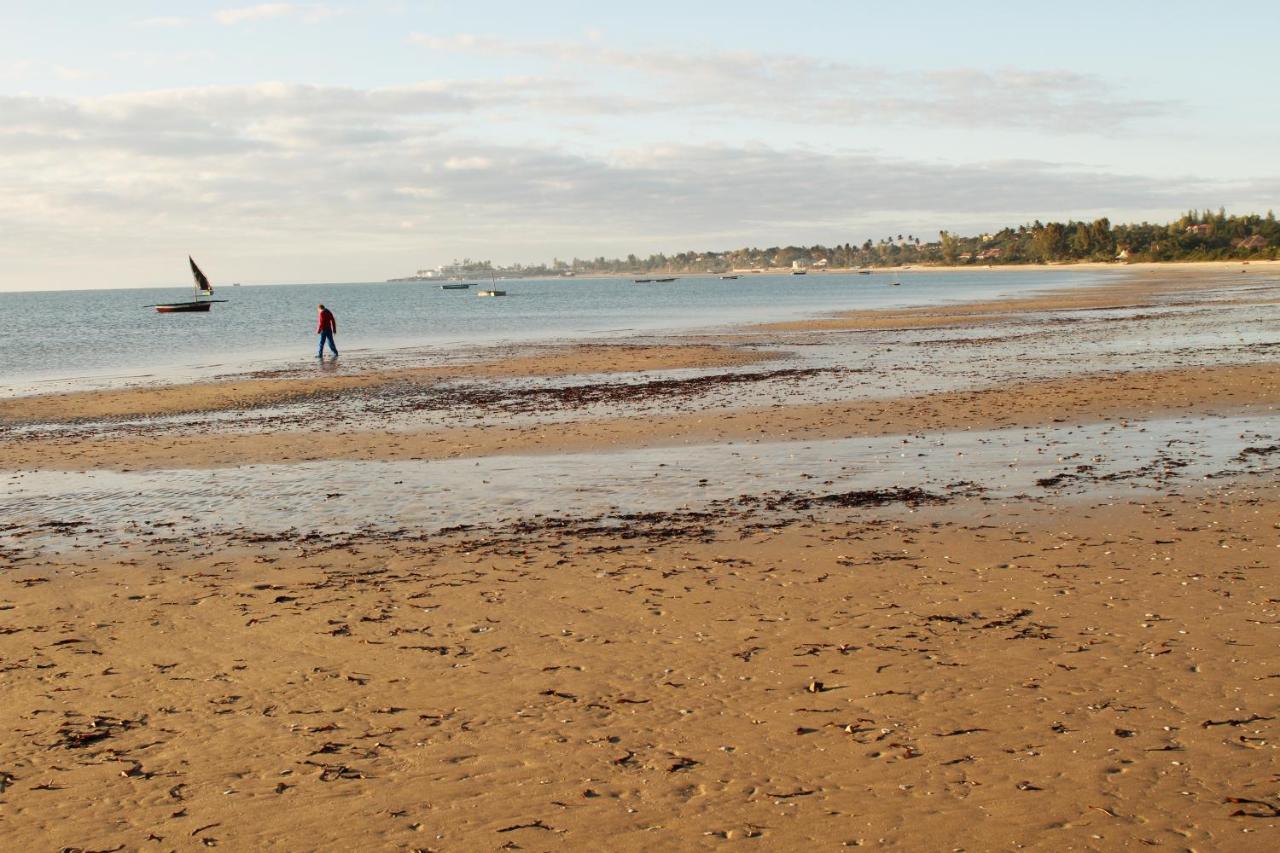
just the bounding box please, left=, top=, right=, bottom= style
left=0, top=416, right=1280, bottom=544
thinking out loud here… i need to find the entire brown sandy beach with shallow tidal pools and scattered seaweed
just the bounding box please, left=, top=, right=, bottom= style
left=0, top=264, right=1280, bottom=850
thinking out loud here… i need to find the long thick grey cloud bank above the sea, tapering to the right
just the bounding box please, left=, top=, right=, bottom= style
left=0, top=83, right=1239, bottom=242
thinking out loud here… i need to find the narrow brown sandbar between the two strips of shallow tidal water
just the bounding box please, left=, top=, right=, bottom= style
left=0, top=365, right=1280, bottom=470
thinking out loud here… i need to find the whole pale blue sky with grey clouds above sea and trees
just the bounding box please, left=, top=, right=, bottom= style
left=0, top=0, right=1280, bottom=291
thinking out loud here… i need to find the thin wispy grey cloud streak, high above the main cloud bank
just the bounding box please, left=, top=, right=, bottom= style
left=410, top=33, right=1174, bottom=133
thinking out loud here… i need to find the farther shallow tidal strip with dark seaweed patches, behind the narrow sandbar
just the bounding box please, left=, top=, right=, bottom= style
left=12, top=284, right=1280, bottom=445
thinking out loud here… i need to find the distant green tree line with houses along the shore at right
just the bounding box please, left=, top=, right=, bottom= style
left=435, top=209, right=1280, bottom=275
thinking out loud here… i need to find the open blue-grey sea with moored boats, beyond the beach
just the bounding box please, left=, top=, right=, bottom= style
left=0, top=270, right=1105, bottom=396
